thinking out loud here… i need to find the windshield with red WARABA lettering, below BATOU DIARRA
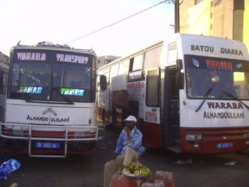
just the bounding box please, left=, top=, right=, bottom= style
left=184, top=55, right=249, bottom=100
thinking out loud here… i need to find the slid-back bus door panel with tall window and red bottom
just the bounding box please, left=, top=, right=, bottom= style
left=143, top=68, right=162, bottom=149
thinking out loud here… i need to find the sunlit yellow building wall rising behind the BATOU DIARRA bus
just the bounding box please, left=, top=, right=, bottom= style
left=180, top=0, right=249, bottom=49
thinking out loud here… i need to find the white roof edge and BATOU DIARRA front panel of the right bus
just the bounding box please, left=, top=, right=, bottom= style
left=99, top=33, right=249, bottom=70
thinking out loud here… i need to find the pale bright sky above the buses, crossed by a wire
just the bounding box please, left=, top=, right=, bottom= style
left=0, top=0, right=174, bottom=56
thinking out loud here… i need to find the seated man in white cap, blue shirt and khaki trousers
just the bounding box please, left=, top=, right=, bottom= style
left=104, top=116, right=144, bottom=187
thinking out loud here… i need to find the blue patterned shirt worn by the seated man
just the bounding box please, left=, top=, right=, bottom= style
left=115, top=127, right=143, bottom=156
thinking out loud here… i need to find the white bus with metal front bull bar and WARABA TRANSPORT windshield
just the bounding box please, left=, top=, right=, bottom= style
left=0, top=42, right=106, bottom=157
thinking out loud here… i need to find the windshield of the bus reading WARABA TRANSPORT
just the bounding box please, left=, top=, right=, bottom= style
left=8, top=50, right=95, bottom=102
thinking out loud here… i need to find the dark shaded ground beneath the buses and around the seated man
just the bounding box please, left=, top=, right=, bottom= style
left=0, top=128, right=249, bottom=187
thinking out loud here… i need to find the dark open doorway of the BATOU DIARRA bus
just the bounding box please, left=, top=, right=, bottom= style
left=162, top=66, right=183, bottom=152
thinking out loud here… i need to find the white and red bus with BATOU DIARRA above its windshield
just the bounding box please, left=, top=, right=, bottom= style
left=98, top=34, right=249, bottom=153
